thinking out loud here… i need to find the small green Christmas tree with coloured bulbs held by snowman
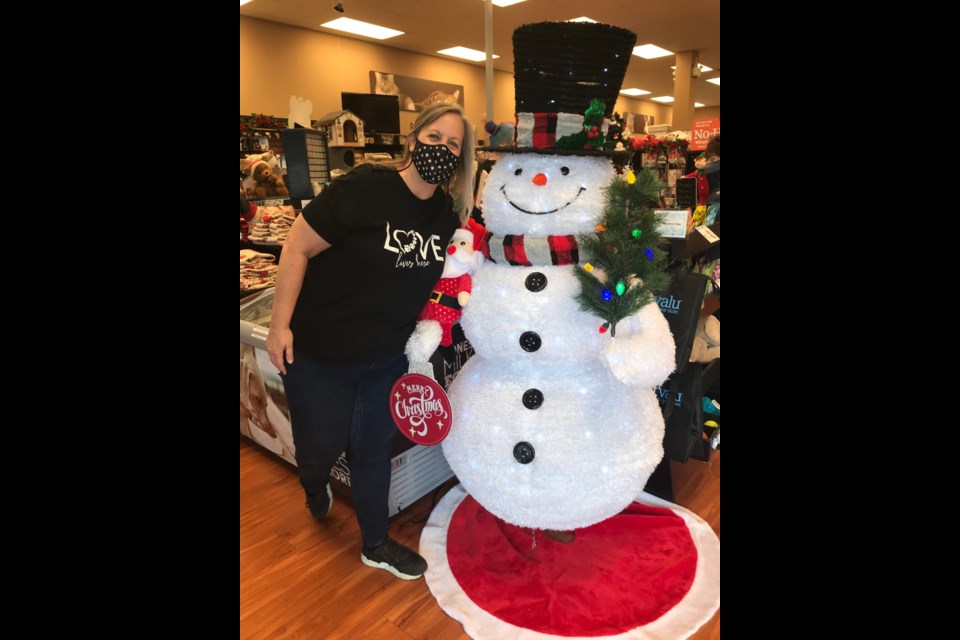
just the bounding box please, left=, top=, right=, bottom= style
left=576, top=169, right=667, bottom=337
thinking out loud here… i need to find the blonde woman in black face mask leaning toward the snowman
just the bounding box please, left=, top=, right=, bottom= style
left=267, top=103, right=474, bottom=580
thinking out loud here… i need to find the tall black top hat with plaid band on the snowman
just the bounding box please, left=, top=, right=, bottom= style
left=481, top=22, right=637, bottom=156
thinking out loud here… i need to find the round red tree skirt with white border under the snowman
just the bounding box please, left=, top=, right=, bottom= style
left=420, top=485, right=720, bottom=640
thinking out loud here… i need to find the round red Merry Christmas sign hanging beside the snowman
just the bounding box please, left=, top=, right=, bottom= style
left=390, top=373, right=453, bottom=446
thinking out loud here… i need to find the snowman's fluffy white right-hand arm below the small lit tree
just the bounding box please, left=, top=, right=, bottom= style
left=603, top=302, right=676, bottom=388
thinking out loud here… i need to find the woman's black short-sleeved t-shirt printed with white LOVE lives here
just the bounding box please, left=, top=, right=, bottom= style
left=290, top=164, right=459, bottom=364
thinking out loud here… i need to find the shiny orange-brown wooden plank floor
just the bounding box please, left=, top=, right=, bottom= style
left=240, top=436, right=720, bottom=640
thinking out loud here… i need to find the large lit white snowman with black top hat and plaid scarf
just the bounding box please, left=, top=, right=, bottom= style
left=442, top=23, right=674, bottom=542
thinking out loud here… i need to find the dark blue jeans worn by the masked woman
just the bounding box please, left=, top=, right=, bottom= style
left=281, top=353, right=408, bottom=546
